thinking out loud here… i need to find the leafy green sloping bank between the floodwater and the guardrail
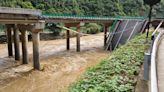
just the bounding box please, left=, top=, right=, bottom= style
left=69, top=34, right=147, bottom=92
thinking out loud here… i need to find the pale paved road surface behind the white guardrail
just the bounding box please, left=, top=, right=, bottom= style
left=157, top=30, right=164, bottom=92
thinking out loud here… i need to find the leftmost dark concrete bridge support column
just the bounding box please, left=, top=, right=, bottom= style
left=6, top=25, right=13, bottom=57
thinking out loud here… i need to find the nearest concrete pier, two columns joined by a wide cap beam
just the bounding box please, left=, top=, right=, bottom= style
left=18, top=22, right=45, bottom=70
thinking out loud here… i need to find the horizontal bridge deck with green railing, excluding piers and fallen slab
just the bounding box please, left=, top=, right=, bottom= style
left=0, top=7, right=164, bottom=24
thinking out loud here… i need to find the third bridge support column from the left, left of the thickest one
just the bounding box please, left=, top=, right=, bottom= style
left=21, top=30, right=29, bottom=64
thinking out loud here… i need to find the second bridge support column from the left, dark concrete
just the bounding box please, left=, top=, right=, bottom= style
left=13, top=25, right=20, bottom=60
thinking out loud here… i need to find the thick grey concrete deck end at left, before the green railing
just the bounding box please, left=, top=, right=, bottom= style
left=0, top=7, right=42, bottom=24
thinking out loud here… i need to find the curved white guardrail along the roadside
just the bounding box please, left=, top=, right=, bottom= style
left=150, top=21, right=164, bottom=92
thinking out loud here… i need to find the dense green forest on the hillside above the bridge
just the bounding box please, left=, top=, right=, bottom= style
left=0, top=0, right=164, bottom=17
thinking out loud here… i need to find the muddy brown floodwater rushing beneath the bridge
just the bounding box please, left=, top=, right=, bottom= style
left=0, top=33, right=109, bottom=92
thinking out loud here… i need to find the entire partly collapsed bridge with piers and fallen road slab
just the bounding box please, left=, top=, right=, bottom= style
left=0, top=7, right=163, bottom=70
